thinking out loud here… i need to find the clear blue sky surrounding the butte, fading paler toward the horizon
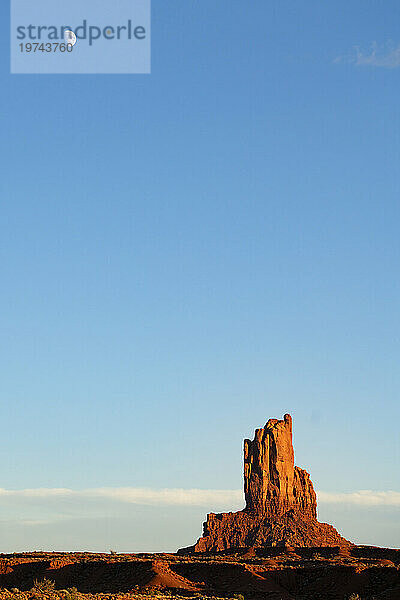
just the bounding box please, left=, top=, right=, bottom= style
left=0, top=0, right=400, bottom=551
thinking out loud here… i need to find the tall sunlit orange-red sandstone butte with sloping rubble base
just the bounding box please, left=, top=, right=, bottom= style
left=179, top=414, right=352, bottom=553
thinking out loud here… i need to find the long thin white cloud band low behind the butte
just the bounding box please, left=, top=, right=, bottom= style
left=0, top=487, right=400, bottom=511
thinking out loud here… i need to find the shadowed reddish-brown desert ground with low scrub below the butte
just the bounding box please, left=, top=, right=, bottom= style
left=0, top=546, right=400, bottom=600
